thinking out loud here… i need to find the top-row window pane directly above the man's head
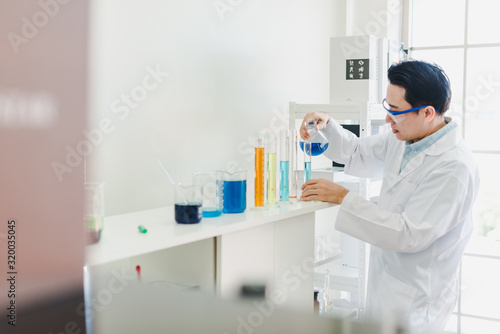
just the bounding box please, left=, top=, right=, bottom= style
left=412, top=0, right=465, bottom=47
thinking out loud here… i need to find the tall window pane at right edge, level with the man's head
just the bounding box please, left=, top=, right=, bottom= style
left=465, top=47, right=500, bottom=150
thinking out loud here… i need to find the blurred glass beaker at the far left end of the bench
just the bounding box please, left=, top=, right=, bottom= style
left=84, top=182, right=104, bottom=244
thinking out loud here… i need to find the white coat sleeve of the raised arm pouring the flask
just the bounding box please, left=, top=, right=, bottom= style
left=323, top=119, right=390, bottom=177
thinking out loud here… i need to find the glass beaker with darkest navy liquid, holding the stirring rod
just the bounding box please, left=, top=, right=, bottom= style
left=174, top=184, right=203, bottom=224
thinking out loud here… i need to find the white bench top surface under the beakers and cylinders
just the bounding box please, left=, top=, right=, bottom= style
left=86, top=202, right=334, bottom=266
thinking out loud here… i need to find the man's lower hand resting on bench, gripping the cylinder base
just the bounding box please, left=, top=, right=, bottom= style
left=300, top=179, right=349, bottom=204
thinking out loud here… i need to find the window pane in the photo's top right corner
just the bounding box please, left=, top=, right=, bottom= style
left=468, top=0, right=500, bottom=44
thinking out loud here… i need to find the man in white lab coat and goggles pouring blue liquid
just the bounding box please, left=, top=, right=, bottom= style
left=300, top=60, right=479, bottom=333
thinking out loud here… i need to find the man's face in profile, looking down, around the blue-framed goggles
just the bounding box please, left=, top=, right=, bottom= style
left=385, top=84, right=425, bottom=141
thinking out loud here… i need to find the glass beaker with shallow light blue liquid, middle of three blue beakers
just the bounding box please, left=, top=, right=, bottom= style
left=193, top=172, right=223, bottom=218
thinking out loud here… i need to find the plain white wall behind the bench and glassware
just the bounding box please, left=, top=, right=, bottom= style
left=87, top=0, right=346, bottom=215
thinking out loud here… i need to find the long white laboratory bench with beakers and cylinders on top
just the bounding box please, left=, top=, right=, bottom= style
left=86, top=201, right=337, bottom=312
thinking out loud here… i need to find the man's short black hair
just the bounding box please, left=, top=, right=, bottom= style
left=387, top=60, right=451, bottom=115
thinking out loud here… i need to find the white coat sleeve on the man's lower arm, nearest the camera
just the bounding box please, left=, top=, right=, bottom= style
left=335, top=164, right=477, bottom=253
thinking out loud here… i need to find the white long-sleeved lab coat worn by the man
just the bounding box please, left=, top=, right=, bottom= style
left=324, top=118, right=479, bottom=333
